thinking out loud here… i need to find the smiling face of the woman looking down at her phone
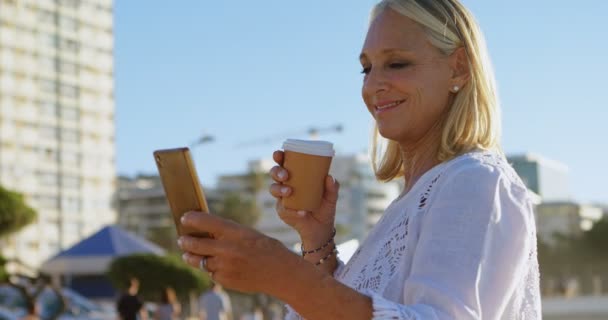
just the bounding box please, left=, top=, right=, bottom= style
left=361, top=9, right=453, bottom=146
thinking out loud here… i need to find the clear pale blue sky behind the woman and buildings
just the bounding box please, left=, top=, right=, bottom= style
left=114, top=0, right=608, bottom=202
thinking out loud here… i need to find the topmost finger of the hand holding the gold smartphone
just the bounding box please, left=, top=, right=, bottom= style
left=180, top=211, right=243, bottom=240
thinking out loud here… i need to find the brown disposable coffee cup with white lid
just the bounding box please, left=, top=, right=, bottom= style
left=282, top=139, right=335, bottom=211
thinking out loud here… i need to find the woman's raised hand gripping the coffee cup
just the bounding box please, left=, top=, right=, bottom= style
left=270, top=151, right=340, bottom=248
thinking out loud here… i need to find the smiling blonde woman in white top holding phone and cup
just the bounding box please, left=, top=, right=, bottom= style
left=180, top=0, right=541, bottom=319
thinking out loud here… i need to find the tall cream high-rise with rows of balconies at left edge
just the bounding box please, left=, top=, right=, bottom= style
left=0, top=0, right=116, bottom=274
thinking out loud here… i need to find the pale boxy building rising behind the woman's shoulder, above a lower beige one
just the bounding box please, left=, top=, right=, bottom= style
left=507, top=153, right=572, bottom=201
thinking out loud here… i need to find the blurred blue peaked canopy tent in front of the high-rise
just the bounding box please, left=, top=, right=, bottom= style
left=40, top=226, right=165, bottom=298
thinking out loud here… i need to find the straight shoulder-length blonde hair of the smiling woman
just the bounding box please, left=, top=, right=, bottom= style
left=370, top=0, right=502, bottom=181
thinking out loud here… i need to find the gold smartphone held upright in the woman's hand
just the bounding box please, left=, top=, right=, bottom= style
left=154, top=148, right=209, bottom=237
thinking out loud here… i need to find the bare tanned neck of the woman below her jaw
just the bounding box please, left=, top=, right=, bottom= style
left=400, top=123, right=442, bottom=193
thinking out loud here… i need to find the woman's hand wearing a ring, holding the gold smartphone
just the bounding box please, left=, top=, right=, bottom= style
left=178, top=212, right=301, bottom=293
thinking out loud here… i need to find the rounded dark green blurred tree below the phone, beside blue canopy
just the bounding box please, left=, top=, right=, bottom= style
left=107, top=254, right=211, bottom=301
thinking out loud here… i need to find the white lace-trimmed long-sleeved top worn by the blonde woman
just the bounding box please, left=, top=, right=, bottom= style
left=286, top=151, right=542, bottom=320
